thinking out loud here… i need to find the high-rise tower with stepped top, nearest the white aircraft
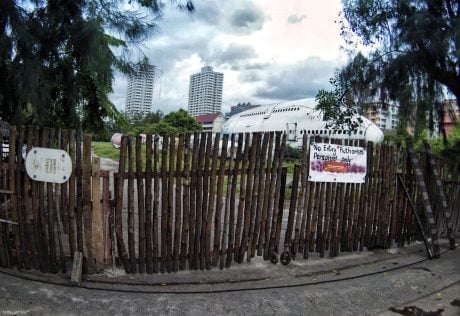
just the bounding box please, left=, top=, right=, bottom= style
left=188, top=66, right=224, bottom=117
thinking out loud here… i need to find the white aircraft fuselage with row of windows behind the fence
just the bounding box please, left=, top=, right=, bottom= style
left=222, top=99, right=383, bottom=147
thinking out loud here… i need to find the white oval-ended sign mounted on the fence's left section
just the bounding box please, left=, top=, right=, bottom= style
left=26, top=147, right=72, bottom=183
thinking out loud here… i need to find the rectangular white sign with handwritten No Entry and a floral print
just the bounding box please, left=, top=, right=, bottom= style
left=308, top=143, right=367, bottom=183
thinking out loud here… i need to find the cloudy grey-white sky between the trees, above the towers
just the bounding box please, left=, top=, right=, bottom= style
left=111, top=0, right=346, bottom=113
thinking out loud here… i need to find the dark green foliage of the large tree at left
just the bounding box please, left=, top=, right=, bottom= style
left=0, top=0, right=194, bottom=132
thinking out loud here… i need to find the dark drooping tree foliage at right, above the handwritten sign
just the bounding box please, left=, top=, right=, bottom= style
left=320, top=0, right=460, bottom=135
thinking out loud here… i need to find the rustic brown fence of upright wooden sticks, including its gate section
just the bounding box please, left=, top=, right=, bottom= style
left=0, top=127, right=460, bottom=273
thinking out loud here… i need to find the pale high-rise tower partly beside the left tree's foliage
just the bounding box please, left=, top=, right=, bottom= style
left=125, top=65, right=155, bottom=117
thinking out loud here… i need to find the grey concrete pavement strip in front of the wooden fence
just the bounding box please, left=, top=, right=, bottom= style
left=0, top=239, right=460, bottom=315
